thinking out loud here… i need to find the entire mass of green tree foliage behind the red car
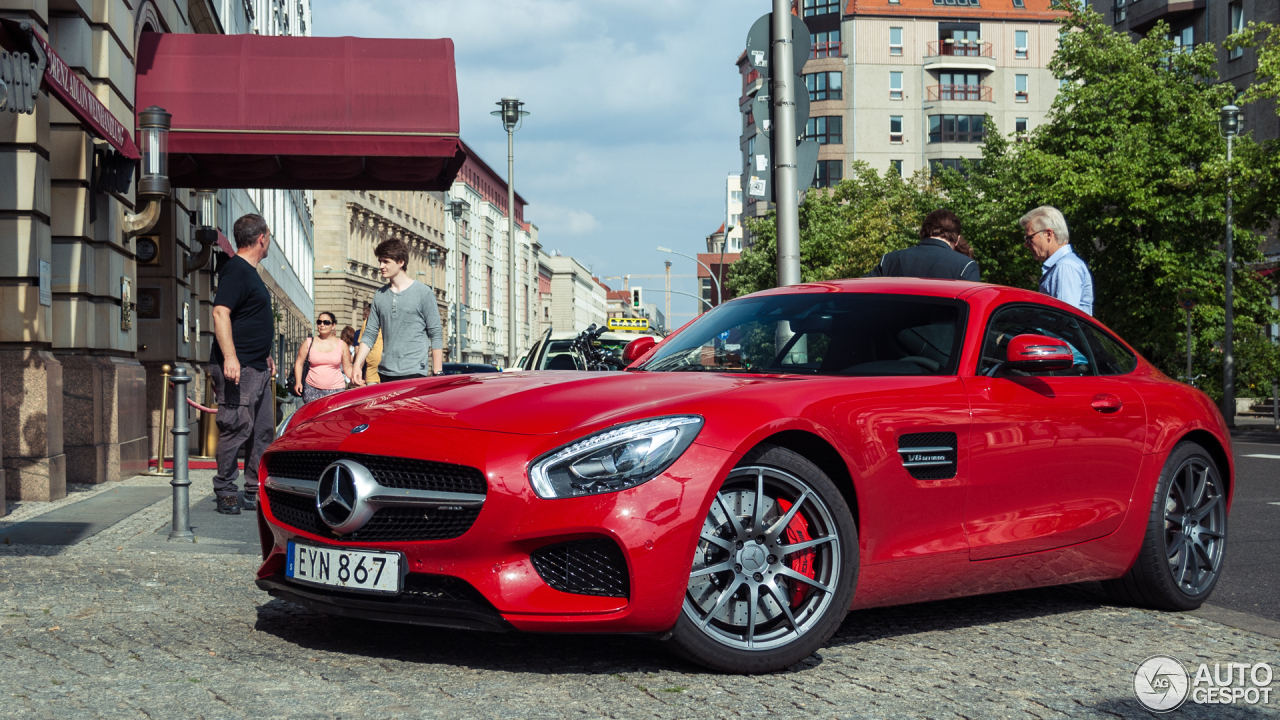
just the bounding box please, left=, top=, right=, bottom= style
left=730, top=8, right=1280, bottom=396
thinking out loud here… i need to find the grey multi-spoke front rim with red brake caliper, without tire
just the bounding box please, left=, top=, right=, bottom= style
left=684, top=466, right=842, bottom=651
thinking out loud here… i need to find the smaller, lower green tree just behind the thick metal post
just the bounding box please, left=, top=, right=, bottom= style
left=727, top=163, right=938, bottom=296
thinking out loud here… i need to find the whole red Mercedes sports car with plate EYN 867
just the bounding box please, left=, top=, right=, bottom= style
left=257, top=279, right=1233, bottom=673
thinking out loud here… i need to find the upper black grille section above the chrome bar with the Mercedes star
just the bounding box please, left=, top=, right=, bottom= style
left=266, top=451, right=489, bottom=495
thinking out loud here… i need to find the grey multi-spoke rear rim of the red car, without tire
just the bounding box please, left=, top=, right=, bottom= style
left=1165, top=456, right=1226, bottom=596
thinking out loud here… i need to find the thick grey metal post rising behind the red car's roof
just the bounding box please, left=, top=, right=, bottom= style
left=769, top=0, right=800, bottom=287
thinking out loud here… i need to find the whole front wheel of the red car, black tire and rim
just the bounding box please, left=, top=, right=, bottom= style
left=667, top=446, right=858, bottom=674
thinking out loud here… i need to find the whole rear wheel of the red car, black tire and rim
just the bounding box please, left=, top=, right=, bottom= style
left=1102, top=442, right=1226, bottom=611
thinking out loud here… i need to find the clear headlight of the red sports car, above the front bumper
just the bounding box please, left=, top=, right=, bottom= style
left=529, top=415, right=703, bottom=498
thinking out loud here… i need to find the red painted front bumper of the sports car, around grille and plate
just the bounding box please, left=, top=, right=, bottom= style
left=259, top=424, right=736, bottom=633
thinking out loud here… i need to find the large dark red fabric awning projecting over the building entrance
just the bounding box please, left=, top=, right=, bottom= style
left=136, top=32, right=466, bottom=190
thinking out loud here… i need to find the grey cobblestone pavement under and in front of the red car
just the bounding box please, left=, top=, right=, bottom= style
left=0, top=478, right=1280, bottom=719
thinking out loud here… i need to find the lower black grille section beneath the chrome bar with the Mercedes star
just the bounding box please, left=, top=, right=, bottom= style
left=265, top=487, right=480, bottom=542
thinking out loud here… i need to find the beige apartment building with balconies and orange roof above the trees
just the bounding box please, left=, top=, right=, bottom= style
left=737, top=0, right=1062, bottom=222
